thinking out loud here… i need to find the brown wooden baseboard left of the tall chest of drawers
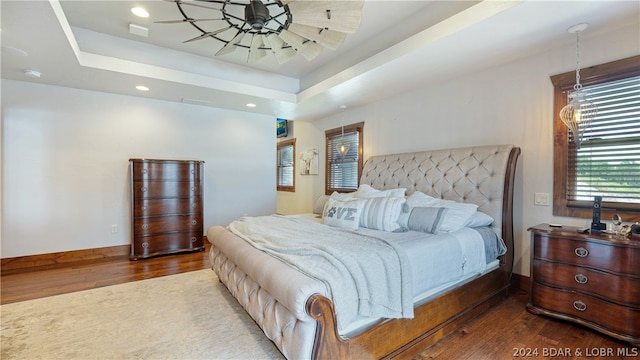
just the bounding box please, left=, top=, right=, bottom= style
left=0, top=245, right=131, bottom=275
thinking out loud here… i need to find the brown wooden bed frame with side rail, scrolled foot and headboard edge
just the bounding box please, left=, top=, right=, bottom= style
left=210, top=145, right=520, bottom=359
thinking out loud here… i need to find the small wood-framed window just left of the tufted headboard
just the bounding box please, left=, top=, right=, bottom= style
left=325, top=123, right=364, bottom=195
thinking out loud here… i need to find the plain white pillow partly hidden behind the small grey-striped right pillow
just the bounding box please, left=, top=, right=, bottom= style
left=405, top=191, right=478, bottom=232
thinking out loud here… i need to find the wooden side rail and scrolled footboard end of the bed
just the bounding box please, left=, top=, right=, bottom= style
left=307, top=269, right=508, bottom=359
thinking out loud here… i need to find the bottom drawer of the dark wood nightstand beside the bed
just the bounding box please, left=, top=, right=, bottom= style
left=532, top=282, right=640, bottom=338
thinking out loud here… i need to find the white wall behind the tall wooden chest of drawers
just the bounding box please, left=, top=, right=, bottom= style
left=1, top=80, right=276, bottom=258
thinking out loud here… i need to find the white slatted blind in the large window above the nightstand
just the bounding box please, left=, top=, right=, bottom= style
left=568, top=76, right=640, bottom=203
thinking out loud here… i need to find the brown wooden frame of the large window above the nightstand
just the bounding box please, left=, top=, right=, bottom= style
left=551, top=55, right=640, bottom=222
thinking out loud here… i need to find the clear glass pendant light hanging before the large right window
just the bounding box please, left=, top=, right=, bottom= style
left=560, top=23, right=598, bottom=148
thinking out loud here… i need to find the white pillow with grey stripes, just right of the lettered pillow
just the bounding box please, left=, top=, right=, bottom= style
left=360, top=197, right=406, bottom=231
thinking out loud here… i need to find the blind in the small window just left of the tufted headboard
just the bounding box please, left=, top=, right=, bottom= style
left=327, top=129, right=360, bottom=191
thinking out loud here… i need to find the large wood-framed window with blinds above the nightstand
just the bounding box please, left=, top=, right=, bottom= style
left=551, top=56, right=640, bottom=221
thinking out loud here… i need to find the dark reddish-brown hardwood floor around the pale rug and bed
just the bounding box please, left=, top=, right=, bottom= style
left=0, top=243, right=640, bottom=360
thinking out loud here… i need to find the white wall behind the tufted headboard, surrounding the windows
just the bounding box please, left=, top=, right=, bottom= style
left=278, top=24, right=640, bottom=276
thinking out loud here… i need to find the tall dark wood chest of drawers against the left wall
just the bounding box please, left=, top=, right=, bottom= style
left=129, top=159, right=204, bottom=260
